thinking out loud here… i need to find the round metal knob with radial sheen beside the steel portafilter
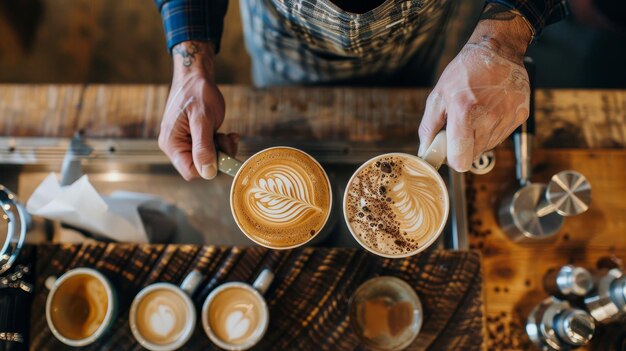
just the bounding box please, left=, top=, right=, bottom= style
left=546, top=171, right=591, bottom=216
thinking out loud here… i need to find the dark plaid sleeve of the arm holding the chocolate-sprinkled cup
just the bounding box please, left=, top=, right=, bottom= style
left=487, top=0, right=569, bottom=39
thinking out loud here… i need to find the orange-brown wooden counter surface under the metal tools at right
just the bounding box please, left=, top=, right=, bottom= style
left=468, top=149, right=626, bottom=350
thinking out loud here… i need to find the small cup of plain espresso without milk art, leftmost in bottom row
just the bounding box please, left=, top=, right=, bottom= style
left=46, top=268, right=118, bottom=347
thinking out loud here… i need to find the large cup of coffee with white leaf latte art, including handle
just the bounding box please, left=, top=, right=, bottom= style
left=218, top=146, right=332, bottom=249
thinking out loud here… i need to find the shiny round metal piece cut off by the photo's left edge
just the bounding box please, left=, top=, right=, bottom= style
left=0, top=185, right=28, bottom=274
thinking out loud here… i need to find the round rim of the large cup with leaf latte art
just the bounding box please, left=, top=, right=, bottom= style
left=229, top=146, right=333, bottom=250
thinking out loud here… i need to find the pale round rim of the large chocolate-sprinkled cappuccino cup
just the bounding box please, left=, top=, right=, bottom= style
left=342, top=152, right=450, bottom=258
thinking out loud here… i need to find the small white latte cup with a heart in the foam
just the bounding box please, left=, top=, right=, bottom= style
left=201, top=269, right=274, bottom=350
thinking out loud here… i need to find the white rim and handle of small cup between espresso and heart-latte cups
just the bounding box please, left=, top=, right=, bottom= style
left=128, top=270, right=202, bottom=351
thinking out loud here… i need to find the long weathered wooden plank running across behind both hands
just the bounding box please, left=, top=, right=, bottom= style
left=0, top=85, right=626, bottom=148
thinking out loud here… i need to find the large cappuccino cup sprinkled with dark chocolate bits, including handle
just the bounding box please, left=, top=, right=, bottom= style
left=343, top=131, right=450, bottom=258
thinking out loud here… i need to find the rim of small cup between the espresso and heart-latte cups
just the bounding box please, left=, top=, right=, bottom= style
left=128, top=282, right=196, bottom=351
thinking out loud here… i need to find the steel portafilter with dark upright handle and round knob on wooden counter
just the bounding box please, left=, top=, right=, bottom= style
left=498, top=58, right=591, bottom=243
